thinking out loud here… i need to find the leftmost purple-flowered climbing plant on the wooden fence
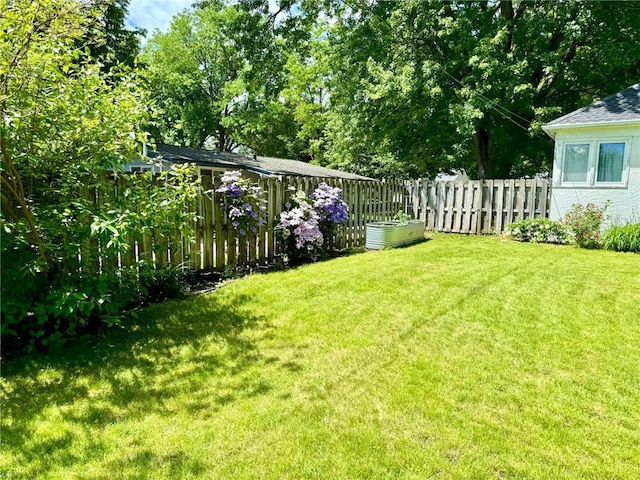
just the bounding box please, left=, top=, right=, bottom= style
left=216, top=170, right=267, bottom=235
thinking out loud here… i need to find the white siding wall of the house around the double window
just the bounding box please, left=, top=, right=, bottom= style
left=549, top=126, right=640, bottom=224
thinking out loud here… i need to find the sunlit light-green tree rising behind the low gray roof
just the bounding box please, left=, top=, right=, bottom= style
left=143, top=1, right=310, bottom=155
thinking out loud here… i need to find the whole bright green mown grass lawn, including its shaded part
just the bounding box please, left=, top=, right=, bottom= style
left=0, top=235, right=640, bottom=479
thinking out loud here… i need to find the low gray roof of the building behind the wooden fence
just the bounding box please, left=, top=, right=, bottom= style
left=150, top=145, right=373, bottom=180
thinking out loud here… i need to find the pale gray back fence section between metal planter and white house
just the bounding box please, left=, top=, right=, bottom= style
left=406, top=179, right=551, bottom=234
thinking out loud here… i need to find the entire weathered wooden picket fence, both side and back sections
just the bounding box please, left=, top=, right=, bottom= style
left=57, top=175, right=550, bottom=271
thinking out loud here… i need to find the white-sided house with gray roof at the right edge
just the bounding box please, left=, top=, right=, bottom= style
left=542, top=83, right=640, bottom=224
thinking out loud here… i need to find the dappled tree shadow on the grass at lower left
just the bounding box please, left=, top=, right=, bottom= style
left=0, top=295, right=280, bottom=478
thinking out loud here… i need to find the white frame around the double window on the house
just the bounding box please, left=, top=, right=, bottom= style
left=556, top=137, right=631, bottom=188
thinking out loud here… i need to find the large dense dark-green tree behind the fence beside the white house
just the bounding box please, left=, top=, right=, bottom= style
left=318, top=0, right=640, bottom=178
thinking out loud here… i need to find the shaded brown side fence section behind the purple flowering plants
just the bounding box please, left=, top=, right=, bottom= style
left=120, top=175, right=407, bottom=271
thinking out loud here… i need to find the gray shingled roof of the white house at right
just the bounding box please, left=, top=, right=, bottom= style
left=545, top=83, right=640, bottom=130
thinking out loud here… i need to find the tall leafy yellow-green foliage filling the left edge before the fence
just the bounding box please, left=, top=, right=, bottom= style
left=0, top=0, right=199, bottom=350
